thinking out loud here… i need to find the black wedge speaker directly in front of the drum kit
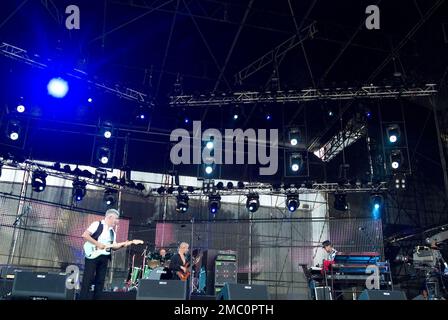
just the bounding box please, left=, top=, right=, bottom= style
left=137, top=279, right=187, bottom=300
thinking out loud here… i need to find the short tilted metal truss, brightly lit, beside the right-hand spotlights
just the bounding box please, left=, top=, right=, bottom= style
left=314, top=119, right=367, bottom=162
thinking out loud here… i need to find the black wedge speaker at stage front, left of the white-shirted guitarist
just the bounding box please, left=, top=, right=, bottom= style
left=11, top=271, right=69, bottom=300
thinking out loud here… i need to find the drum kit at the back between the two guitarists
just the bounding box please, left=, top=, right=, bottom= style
left=128, top=250, right=173, bottom=289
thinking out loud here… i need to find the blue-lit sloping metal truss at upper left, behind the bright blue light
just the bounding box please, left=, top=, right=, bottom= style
left=0, top=42, right=151, bottom=105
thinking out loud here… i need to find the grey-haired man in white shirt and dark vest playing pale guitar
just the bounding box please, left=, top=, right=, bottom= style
left=80, top=209, right=132, bottom=300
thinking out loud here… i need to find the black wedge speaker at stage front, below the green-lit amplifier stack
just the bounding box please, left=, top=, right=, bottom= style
left=217, top=283, right=269, bottom=300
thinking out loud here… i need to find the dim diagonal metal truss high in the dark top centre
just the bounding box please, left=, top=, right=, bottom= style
left=235, top=22, right=317, bottom=84
